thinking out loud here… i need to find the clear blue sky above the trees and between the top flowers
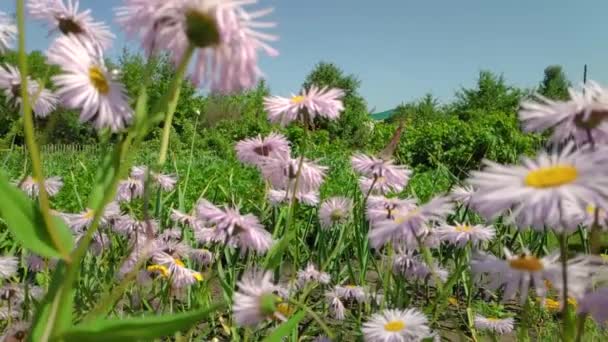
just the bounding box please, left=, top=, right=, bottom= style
left=0, top=0, right=608, bottom=111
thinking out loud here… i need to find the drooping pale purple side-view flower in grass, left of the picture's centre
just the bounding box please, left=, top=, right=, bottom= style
left=197, top=200, right=274, bottom=254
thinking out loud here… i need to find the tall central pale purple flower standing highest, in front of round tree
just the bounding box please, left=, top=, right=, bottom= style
left=264, top=85, right=344, bottom=126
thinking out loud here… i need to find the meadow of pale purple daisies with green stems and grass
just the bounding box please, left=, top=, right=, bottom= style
left=0, top=0, right=608, bottom=342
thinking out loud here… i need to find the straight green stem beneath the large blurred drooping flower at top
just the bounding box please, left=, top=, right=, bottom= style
left=158, top=45, right=194, bottom=168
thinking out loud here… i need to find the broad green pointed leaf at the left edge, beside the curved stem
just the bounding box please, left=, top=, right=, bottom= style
left=0, top=174, right=73, bottom=258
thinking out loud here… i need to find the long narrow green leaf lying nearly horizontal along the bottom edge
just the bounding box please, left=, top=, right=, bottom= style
left=59, top=304, right=223, bottom=342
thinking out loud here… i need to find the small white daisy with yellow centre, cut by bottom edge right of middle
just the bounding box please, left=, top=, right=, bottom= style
left=361, top=309, right=431, bottom=342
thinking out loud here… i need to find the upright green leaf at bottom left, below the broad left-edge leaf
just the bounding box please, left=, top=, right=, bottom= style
left=28, top=261, right=74, bottom=342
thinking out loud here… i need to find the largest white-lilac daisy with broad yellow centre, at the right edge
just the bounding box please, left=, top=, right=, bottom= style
left=470, top=144, right=608, bottom=231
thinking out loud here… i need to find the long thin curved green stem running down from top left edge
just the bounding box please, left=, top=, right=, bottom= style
left=17, top=0, right=71, bottom=262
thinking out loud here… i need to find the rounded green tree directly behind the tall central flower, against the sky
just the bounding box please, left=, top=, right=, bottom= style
left=302, top=62, right=370, bottom=146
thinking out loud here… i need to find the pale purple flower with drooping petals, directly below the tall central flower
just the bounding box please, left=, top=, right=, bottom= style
left=261, top=156, right=327, bottom=194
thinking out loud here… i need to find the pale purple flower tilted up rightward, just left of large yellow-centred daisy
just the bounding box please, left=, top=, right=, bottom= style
left=369, top=197, right=452, bottom=248
